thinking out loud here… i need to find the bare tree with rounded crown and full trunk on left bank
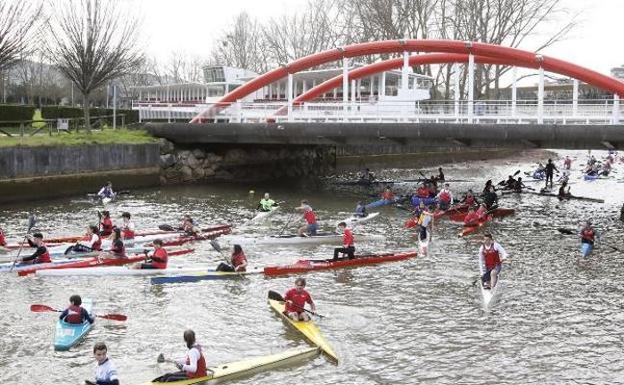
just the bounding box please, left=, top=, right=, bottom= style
left=48, top=0, right=142, bottom=132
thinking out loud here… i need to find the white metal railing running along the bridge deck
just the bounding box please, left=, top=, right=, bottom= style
left=133, top=99, right=623, bottom=124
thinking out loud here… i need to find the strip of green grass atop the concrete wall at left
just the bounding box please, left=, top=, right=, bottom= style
left=0, top=129, right=158, bottom=147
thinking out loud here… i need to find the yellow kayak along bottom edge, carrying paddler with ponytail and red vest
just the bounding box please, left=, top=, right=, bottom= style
left=143, top=347, right=320, bottom=385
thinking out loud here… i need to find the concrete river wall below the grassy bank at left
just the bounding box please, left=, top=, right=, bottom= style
left=0, top=143, right=160, bottom=203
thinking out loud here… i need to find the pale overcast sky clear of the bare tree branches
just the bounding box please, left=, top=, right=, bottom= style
left=135, top=0, right=624, bottom=78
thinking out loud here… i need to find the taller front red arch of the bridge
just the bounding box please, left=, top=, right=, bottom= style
left=191, top=39, right=624, bottom=123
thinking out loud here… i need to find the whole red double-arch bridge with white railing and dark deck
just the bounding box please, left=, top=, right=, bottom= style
left=139, top=39, right=624, bottom=148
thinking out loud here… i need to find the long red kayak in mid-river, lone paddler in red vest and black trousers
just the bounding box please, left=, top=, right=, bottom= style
left=264, top=251, right=417, bottom=276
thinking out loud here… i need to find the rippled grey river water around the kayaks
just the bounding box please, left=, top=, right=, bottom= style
left=0, top=148, right=624, bottom=384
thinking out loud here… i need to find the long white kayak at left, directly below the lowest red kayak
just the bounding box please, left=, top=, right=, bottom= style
left=35, top=266, right=214, bottom=277
